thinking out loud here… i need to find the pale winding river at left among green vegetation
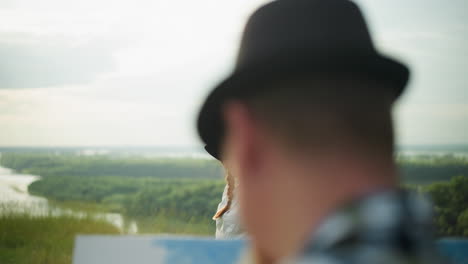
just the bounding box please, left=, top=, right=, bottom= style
left=0, top=166, right=138, bottom=234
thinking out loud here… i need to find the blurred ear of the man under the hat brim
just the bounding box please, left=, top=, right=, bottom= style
left=223, top=101, right=261, bottom=177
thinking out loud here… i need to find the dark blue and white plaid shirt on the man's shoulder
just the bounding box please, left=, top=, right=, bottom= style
left=280, top=191, right=442, bottom=264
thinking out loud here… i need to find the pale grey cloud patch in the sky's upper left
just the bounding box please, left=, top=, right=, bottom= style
left=0, top=34, right=114, bottom=89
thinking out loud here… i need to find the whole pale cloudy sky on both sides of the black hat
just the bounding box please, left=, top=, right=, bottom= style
left=0, top=0, right=468, bottom=146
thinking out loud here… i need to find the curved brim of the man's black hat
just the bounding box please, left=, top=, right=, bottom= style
left=197, top=54, right=409, bottom=158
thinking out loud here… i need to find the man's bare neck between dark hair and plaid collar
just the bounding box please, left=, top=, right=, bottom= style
left=259, top=152, right=397, bottom=263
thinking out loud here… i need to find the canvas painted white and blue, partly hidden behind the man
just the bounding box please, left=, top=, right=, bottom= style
left=73, top=235, right=468, bottom=264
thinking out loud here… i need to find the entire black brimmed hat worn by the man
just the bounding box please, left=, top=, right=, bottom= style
left=197, top=0, right=409, bottom=157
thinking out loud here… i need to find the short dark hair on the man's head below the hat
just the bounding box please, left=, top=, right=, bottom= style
left=246, top=75, right=395, bottom=158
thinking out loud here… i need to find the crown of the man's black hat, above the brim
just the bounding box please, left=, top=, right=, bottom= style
left=237, top=0, right=376, bottom=68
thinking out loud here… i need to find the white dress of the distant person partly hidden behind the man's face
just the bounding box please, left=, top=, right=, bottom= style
left=216, top=186, right=244, bottom=239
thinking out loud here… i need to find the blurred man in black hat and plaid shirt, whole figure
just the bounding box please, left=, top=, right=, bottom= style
left=198, top=0, right=438, bottom=264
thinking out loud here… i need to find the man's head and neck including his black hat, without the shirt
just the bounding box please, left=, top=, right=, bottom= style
left=197, top=0, right=409, bottom=257
